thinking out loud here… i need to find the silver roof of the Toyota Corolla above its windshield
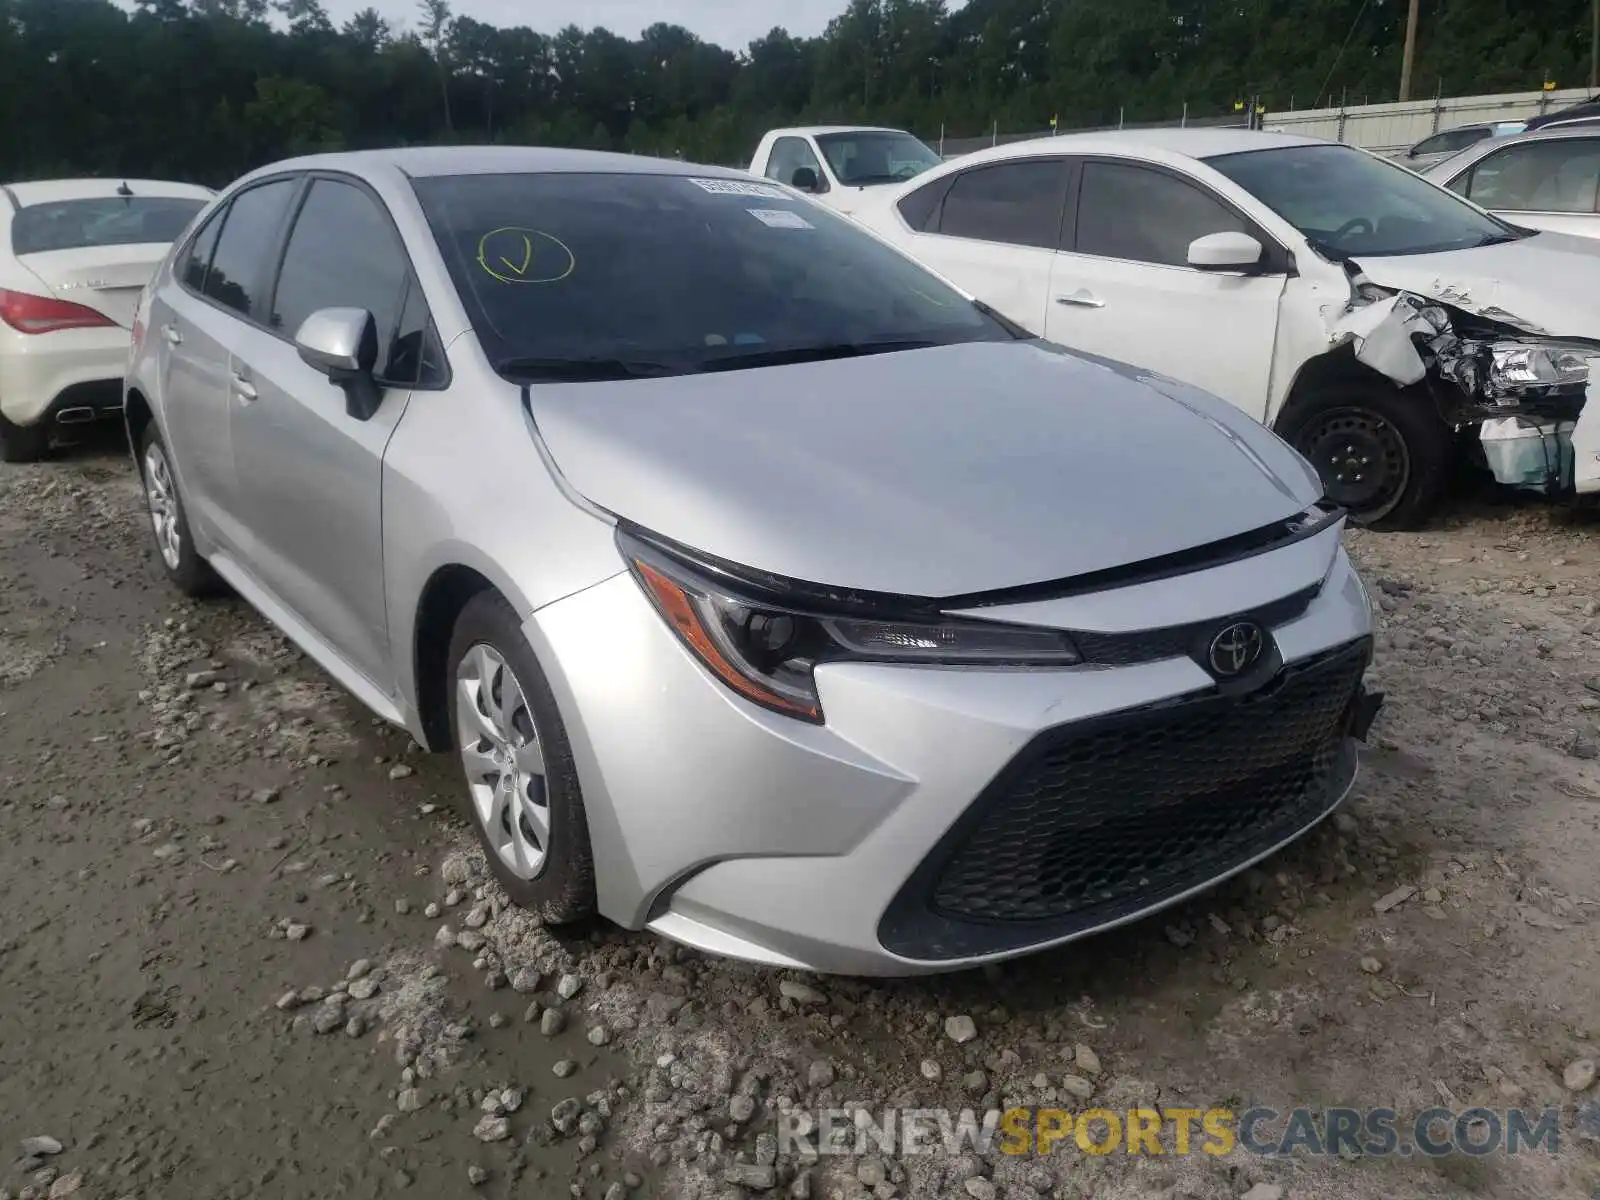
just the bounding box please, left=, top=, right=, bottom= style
left=235, top=146, right=761, bottom=181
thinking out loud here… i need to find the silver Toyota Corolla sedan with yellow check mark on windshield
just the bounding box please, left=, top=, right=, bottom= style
left=126, top=147, right=1379, bottom=974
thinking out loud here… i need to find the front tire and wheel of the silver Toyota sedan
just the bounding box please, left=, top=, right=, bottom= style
left=446, top=592, right=595, bottom=925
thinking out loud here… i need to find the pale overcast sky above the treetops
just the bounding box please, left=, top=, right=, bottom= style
left=323, top=0, right=845, bottom=50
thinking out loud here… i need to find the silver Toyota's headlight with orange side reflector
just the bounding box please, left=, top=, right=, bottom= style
left=618, top=531, right=1083, bottom=723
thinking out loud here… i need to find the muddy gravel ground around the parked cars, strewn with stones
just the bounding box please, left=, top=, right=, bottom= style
left=0, top=438, right=1600, bottom=1200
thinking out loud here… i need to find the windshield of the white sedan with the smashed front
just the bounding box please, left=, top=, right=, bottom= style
left=1206, top=146, right=1523, bottom=259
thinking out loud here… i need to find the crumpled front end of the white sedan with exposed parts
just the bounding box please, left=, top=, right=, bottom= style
left=1330, top=272, right=1600, bottom=498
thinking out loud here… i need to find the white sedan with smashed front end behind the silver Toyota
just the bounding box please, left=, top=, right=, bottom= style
left=856, top=130, right=1600, bottom=528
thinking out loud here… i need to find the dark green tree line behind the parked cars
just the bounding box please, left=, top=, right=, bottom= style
left=0, top=0, right=1590, bottom=184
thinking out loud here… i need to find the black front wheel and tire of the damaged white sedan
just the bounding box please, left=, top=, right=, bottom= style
left=1278, top=382, right=1454, bottom=530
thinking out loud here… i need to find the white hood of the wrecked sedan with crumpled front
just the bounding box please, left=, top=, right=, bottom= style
left=1357, top=234, right=1600, bottom=338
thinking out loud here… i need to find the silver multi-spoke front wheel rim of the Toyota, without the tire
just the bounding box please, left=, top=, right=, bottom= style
left=456, top=642, right=550, bottom=878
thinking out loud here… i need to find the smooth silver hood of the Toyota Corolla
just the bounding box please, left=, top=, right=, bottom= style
left=530, top=342, right=1320, bottom=597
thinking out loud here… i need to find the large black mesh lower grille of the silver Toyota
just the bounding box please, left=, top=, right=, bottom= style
left=880, top=638, right=1371, bottom=957
